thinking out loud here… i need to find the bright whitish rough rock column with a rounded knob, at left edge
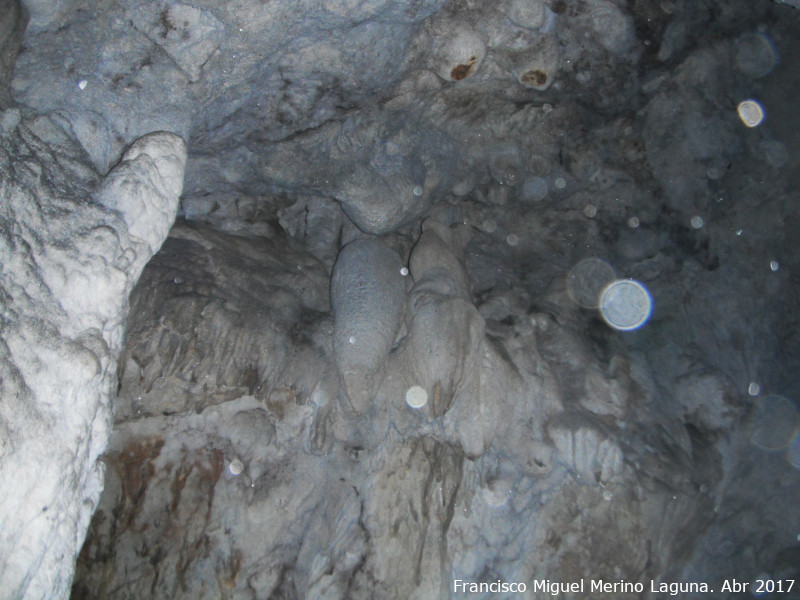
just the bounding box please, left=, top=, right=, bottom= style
left=0, top=117, right=186, bottom=600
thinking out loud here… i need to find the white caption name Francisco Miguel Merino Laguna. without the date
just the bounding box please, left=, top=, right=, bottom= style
left=453, top=579, right=720, bottom=596
